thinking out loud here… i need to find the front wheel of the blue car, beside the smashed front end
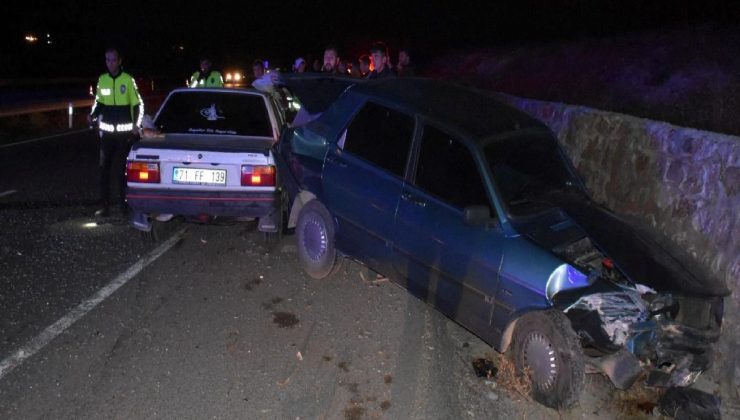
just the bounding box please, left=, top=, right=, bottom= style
left=512, top=311, right=584, bottom=409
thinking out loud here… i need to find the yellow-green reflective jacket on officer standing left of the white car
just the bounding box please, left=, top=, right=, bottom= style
left=91, top=71, right=144, bottom=133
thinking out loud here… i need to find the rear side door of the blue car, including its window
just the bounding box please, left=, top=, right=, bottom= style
left=322, top=101, right=414, bottom=272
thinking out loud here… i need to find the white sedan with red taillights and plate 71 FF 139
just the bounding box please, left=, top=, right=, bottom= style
left=126, top=89, right=285, bottom=240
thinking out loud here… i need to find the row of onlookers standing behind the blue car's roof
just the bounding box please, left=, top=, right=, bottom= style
left=292, top=42, right=416, bottom=79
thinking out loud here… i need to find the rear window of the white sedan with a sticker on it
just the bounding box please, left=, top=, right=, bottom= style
left=154, top=89, right=273, bottom=137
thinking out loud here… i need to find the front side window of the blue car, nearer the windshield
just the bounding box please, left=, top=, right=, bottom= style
left=415, top=126, right=489, bottom=209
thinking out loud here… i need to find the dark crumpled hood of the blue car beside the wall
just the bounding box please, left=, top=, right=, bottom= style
left=516, top=191, right=730, bottom=296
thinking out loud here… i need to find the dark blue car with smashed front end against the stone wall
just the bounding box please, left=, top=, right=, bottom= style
left=276, top=76, right=728, bottom=407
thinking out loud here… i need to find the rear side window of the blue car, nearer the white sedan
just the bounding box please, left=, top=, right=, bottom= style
left=340, top=102, right=414, bottom=177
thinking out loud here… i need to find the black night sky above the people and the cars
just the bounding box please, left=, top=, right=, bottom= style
left=0, top=0, right=740, bottom=78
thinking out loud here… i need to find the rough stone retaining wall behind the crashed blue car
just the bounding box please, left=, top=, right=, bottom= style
left=503, top=96, right=740, bottom=405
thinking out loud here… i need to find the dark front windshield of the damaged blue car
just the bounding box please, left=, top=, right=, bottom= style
left=483, top=133, right=573, bottom=216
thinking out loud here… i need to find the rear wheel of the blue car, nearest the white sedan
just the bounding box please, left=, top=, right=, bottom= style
left=295, top=200, right=338, bottom=279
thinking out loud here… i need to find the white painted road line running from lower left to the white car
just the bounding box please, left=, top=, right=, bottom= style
left=0, top=228, right=187, bottom=379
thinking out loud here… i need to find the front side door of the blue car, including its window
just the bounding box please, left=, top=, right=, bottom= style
left=393, top=125, right=504, bottom=340
